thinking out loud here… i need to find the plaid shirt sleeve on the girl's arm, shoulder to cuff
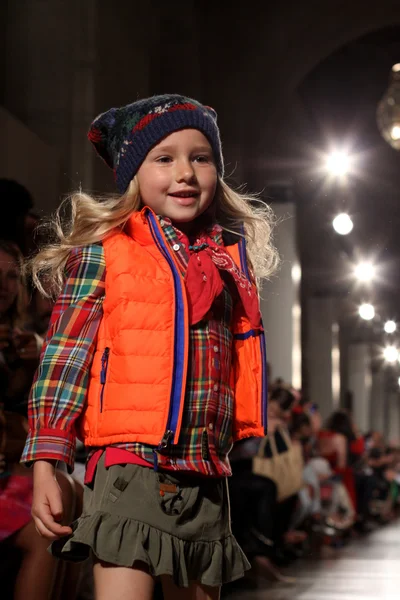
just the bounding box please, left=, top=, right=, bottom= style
left=21, top=244, right=105, bottom=470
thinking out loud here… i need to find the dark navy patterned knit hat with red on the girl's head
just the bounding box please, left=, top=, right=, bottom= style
left=88, top=94, right=224, bottom=194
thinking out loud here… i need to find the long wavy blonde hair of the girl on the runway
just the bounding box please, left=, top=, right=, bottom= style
left=26, top=176, right=279, bottom=296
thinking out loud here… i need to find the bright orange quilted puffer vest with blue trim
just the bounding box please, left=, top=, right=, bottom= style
left=79, top=208, right=266, bottom=449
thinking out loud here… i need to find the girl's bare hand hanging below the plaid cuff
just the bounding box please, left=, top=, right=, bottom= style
left=32, top=460, right=72, bottom=540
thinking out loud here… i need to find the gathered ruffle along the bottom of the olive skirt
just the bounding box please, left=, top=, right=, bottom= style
left=51, top=512, right=250, bottom=587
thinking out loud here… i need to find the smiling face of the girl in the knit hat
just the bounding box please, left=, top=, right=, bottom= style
left=137, top=129, right=218, bottom=224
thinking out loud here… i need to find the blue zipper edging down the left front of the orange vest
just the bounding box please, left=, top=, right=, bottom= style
left=147, top=213, right=186, bottom=452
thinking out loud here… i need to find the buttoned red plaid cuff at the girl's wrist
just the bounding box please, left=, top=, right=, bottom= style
left=21, top=428, right=76, bottom=473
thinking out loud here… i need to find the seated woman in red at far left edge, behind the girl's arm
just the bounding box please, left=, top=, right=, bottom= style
left=0, top=240, right=81, bottom=600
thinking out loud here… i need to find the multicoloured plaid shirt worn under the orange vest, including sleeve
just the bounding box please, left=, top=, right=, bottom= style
left=21, top=218, right=233, bottom=476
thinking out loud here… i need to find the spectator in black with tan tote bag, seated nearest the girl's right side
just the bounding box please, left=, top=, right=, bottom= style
left=229, top=387, right=307, bottom=583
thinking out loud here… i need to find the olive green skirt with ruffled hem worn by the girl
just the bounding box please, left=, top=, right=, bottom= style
left=51, top=453, right=250, bottom=587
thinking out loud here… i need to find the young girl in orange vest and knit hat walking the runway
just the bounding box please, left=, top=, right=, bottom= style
left=23, top=95, right=276, bottom=600
